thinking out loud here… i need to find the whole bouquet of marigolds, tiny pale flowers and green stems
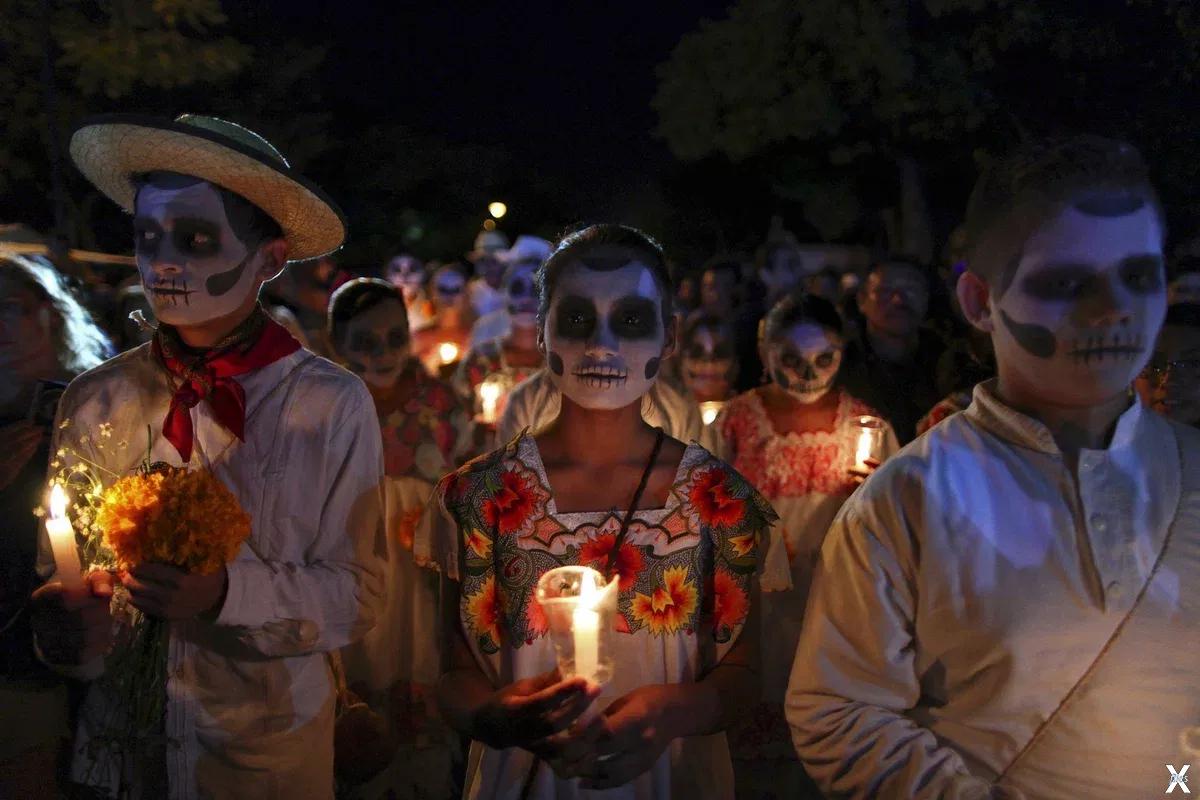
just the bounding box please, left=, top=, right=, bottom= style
left=46, top=428, right=250, bottom=782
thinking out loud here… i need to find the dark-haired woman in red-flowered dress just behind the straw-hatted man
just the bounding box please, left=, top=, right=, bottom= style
left=329, top=278, right=467, bottom=800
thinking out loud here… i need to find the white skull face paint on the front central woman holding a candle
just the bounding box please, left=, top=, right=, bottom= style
left=542, top=257, right=666, bottom=410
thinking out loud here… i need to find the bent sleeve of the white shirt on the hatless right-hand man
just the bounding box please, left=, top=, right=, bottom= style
left=785, top=501, right=974, bottom=800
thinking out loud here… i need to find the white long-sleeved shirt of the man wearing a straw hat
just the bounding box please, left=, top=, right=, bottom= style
left=40, top=344, right=386, bottom=800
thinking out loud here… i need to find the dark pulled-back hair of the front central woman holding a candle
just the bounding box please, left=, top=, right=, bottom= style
left=534, top=223, right=674, bottom=326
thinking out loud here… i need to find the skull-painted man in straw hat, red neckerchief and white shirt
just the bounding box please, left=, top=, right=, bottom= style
left=34, top=115, right=386, bottom=798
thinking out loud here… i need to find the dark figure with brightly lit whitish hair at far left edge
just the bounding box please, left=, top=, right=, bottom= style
left=0, top=254, right=110, bottom=798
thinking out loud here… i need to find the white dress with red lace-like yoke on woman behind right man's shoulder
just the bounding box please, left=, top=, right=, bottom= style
left=714, top=390, right=899, bottom=760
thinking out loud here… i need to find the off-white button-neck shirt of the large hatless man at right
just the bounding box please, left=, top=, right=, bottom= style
left=787, top=381, right=1200, bottom=800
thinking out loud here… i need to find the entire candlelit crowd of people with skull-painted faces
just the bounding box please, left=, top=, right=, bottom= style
left=0, top=109, right=1200, bottom=800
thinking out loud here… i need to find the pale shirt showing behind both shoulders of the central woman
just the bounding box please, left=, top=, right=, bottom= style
left=496, top=369, right=704, bottom=446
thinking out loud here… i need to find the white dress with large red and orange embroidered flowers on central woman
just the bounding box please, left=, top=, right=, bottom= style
left=415, top=433, right=775, bottom=800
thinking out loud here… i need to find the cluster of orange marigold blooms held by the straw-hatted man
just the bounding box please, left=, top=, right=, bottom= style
left=96, top=469, right=250, bottom=575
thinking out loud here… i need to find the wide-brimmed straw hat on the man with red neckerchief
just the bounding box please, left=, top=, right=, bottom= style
left=71, top=114, right=346, bottom=261
